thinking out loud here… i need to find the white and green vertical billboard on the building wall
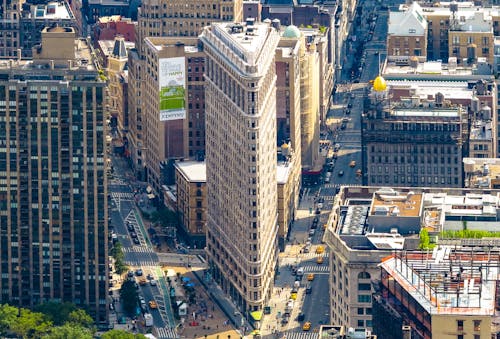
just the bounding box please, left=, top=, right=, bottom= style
left=158, top=57, right=186, bottom=121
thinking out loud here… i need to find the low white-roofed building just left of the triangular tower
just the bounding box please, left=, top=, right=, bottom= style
left=175, top=161, right=207, bottom=248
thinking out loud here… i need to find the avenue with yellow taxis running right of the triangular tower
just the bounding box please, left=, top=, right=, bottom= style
left=262, top=4, right=388, bottom=339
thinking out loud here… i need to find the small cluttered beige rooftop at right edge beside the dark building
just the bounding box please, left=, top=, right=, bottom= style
left=463, top=158, right=500, bottom=189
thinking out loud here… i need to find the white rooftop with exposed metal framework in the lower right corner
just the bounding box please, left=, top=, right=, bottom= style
left=380, top=250, right=499, bottom=316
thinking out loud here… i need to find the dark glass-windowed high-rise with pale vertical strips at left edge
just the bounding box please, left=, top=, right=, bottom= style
left=0, top=27, right=108, bottom=324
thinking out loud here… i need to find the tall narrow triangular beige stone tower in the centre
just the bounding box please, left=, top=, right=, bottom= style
left=201, top=20, right=280, bottom=312
